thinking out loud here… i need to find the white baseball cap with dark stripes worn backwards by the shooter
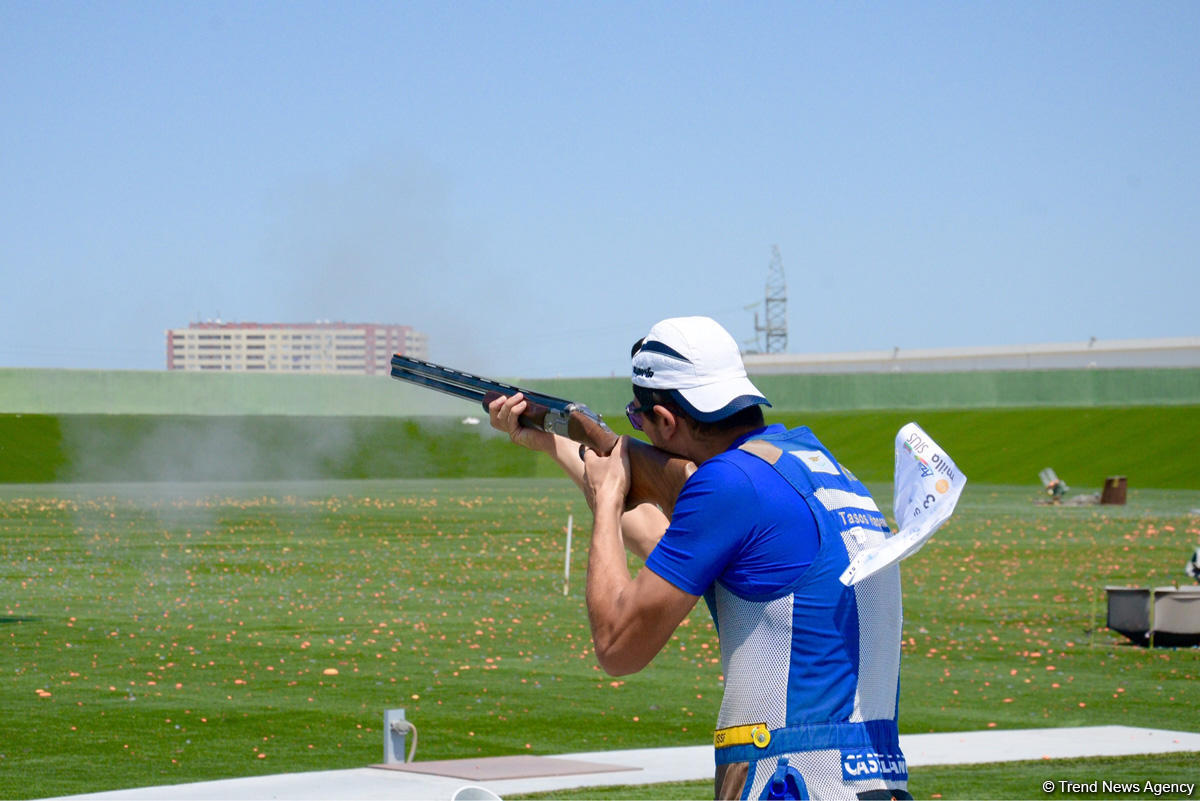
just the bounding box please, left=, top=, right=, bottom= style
left=634, top=317, right=770, bottom=423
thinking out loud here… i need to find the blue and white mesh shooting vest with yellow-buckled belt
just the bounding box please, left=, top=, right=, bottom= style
left=713, top=428, right=908, bottom=799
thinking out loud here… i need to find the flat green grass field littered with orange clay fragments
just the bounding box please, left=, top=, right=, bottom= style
left=0, top=472, right=1200, bottom=799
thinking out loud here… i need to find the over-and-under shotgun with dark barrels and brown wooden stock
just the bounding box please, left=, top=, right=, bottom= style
left=391, top=354, right=696, bottom=517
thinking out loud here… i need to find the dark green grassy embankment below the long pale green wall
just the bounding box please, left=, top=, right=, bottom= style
left=0, top=406, right=1200, bottom=492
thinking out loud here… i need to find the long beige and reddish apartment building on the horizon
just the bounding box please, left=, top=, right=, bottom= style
left=167, top=320, right=430, bottom=375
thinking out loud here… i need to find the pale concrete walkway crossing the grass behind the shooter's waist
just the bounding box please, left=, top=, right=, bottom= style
left=42, top=725, right=1200, bottom=801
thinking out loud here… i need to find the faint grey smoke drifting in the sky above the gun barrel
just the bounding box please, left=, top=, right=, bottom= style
left=260, top=159, right=509, bottom=372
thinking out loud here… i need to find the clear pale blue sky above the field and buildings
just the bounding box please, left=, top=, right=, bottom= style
left=0, top=0, right=1200, bottom=377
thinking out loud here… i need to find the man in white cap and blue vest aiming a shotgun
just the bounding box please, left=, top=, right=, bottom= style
left=488, top=317, right=911, bottom=799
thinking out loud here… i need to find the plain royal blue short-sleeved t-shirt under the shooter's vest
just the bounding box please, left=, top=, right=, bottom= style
left=646, top=424, right=821, bottom=601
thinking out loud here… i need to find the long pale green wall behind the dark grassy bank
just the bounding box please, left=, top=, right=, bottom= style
left=0, top=368, right=1200, bottom=417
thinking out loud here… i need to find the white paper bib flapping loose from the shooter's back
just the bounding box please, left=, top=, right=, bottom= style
left=840, top=423, right=967, bottom=586
